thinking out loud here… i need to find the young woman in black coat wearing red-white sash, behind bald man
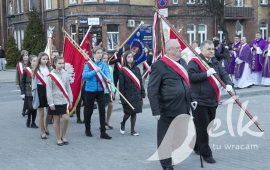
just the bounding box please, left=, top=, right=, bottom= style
left=119, top=51, right=145, bottom=136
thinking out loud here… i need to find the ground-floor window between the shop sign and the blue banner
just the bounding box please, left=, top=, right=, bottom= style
left=107, top=24, right=119, bottom=50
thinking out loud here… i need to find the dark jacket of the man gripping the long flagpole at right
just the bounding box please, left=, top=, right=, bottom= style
left=188, top=54, right=232, bottom=107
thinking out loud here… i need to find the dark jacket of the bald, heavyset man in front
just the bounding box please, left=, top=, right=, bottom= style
left=147, top=60, right=191, bottom=117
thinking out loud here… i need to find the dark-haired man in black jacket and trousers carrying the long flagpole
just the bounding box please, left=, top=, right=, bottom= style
left=188, top=40, right=232, bottom=163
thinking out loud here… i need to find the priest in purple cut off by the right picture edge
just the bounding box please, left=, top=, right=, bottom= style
left=261, top=37, right=270, bottom=86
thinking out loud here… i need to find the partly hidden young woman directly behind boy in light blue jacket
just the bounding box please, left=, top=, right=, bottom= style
left=102, top=52, right=115, bottom=129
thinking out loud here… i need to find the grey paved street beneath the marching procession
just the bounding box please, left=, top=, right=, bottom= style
left=0, top=71, right=270, bottom=170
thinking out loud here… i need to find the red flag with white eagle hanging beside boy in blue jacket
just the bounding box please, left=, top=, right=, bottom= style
left=63, top=37, right=86, bottom=113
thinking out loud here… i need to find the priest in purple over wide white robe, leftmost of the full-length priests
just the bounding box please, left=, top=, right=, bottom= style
left=234, top=37, right=252, bottom=89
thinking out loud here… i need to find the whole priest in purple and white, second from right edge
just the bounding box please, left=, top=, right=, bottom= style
left=250, top=32, right=268, bottom=85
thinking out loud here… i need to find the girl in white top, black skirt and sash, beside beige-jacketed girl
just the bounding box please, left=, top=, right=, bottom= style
left=32, top=52, right=52, bottom=139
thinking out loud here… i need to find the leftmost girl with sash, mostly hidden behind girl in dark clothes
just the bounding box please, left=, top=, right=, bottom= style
left=15, top=50, right=28, bottom=116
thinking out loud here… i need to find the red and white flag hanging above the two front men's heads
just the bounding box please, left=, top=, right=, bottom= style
left=161, top=18, right=195, bottom=63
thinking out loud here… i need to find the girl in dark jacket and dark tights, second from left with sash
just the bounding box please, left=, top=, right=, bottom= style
left=20, top=55, right=38, bottom=128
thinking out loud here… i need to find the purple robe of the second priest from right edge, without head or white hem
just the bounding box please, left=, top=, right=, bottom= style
left=250, top=38, right=268, bottom=72
